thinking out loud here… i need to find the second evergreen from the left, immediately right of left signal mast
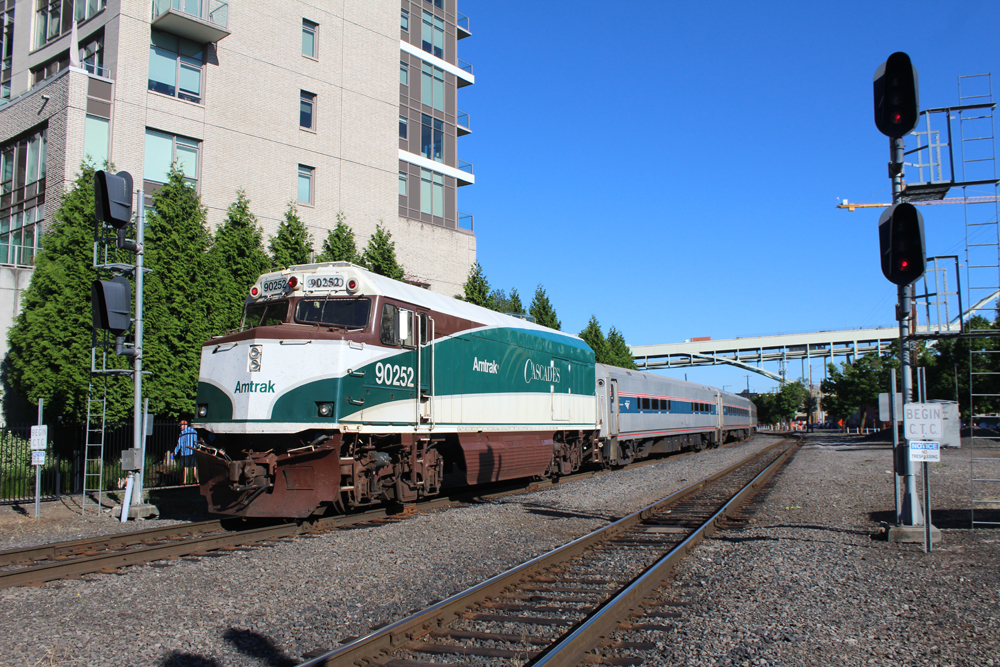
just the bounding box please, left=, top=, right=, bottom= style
left=143, top=165, right=218, bottom=418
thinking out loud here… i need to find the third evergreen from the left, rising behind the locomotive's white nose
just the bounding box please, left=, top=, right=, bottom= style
left=209, top=189, right=271, bottom=335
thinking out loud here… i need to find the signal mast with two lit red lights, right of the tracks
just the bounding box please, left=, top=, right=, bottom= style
left=872, top=51, right=927, bottom=527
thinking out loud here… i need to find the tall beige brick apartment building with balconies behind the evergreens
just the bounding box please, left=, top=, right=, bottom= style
left=0, top=0, right=476, bottom=360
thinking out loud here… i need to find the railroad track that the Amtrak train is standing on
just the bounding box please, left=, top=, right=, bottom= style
left=0, top=443, right=752, bottom=589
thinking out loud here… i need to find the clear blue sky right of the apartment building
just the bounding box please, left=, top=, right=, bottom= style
left=458, top=0, right=1000, bottom=391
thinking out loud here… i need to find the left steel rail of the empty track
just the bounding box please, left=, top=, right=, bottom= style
left=299, top=438, right=788, bottom=667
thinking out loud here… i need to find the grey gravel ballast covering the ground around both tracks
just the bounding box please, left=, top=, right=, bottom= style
left=0, top=435, right=1000, bottom=667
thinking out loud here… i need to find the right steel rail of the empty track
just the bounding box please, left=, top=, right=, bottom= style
left=527, top=441, right=801, bottom=667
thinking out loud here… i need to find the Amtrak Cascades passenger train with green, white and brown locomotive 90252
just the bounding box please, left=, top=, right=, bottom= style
left=192, top=262, right=757, bottom=518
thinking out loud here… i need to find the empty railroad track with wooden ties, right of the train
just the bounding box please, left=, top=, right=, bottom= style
left=301, top=439, right=801, bottom=667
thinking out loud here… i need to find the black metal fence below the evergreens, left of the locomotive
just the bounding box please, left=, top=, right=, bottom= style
left=0, top=421, right=189, bottom=505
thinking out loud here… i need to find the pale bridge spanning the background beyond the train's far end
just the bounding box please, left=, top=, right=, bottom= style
left=630, top=327, right=899, bottom=382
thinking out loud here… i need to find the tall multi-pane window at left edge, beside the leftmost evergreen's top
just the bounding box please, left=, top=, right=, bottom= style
left=0, top=129, right=48, bottom=266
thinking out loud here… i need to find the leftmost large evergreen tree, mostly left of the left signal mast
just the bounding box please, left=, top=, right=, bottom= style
left=3, top=163, right=132, bottom=423
